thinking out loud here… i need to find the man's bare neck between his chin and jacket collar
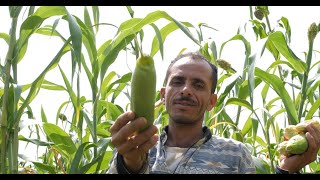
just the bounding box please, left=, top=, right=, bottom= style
left=166, top=124, right=204, bottom=148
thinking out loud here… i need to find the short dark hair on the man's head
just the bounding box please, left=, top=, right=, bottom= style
left=164, top=52, right=218, bottom=94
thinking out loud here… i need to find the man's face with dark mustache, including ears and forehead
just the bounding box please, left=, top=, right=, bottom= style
left=160, top=57, right=216, bottom=124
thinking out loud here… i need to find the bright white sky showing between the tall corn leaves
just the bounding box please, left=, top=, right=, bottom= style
left=0, top=6, right=320, bottom=160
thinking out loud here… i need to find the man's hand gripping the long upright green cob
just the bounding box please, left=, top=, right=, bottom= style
left=110, top=112, right=158, bottom=173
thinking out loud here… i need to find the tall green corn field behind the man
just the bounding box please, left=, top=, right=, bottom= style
left=0, top=6, right=320, bottom=174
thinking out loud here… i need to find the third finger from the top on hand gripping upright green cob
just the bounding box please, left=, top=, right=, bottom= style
left=117, top=125, right=157, bottom=154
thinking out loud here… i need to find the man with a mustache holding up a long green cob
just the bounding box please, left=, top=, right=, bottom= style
left=108, top=53, right=320, bottom=174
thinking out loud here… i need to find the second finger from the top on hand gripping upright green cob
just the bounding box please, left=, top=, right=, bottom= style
left=111, top=117, right=147, bottom=147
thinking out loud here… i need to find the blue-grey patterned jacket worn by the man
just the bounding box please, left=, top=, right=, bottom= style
left=108, top=126, right=255, bottom=174
